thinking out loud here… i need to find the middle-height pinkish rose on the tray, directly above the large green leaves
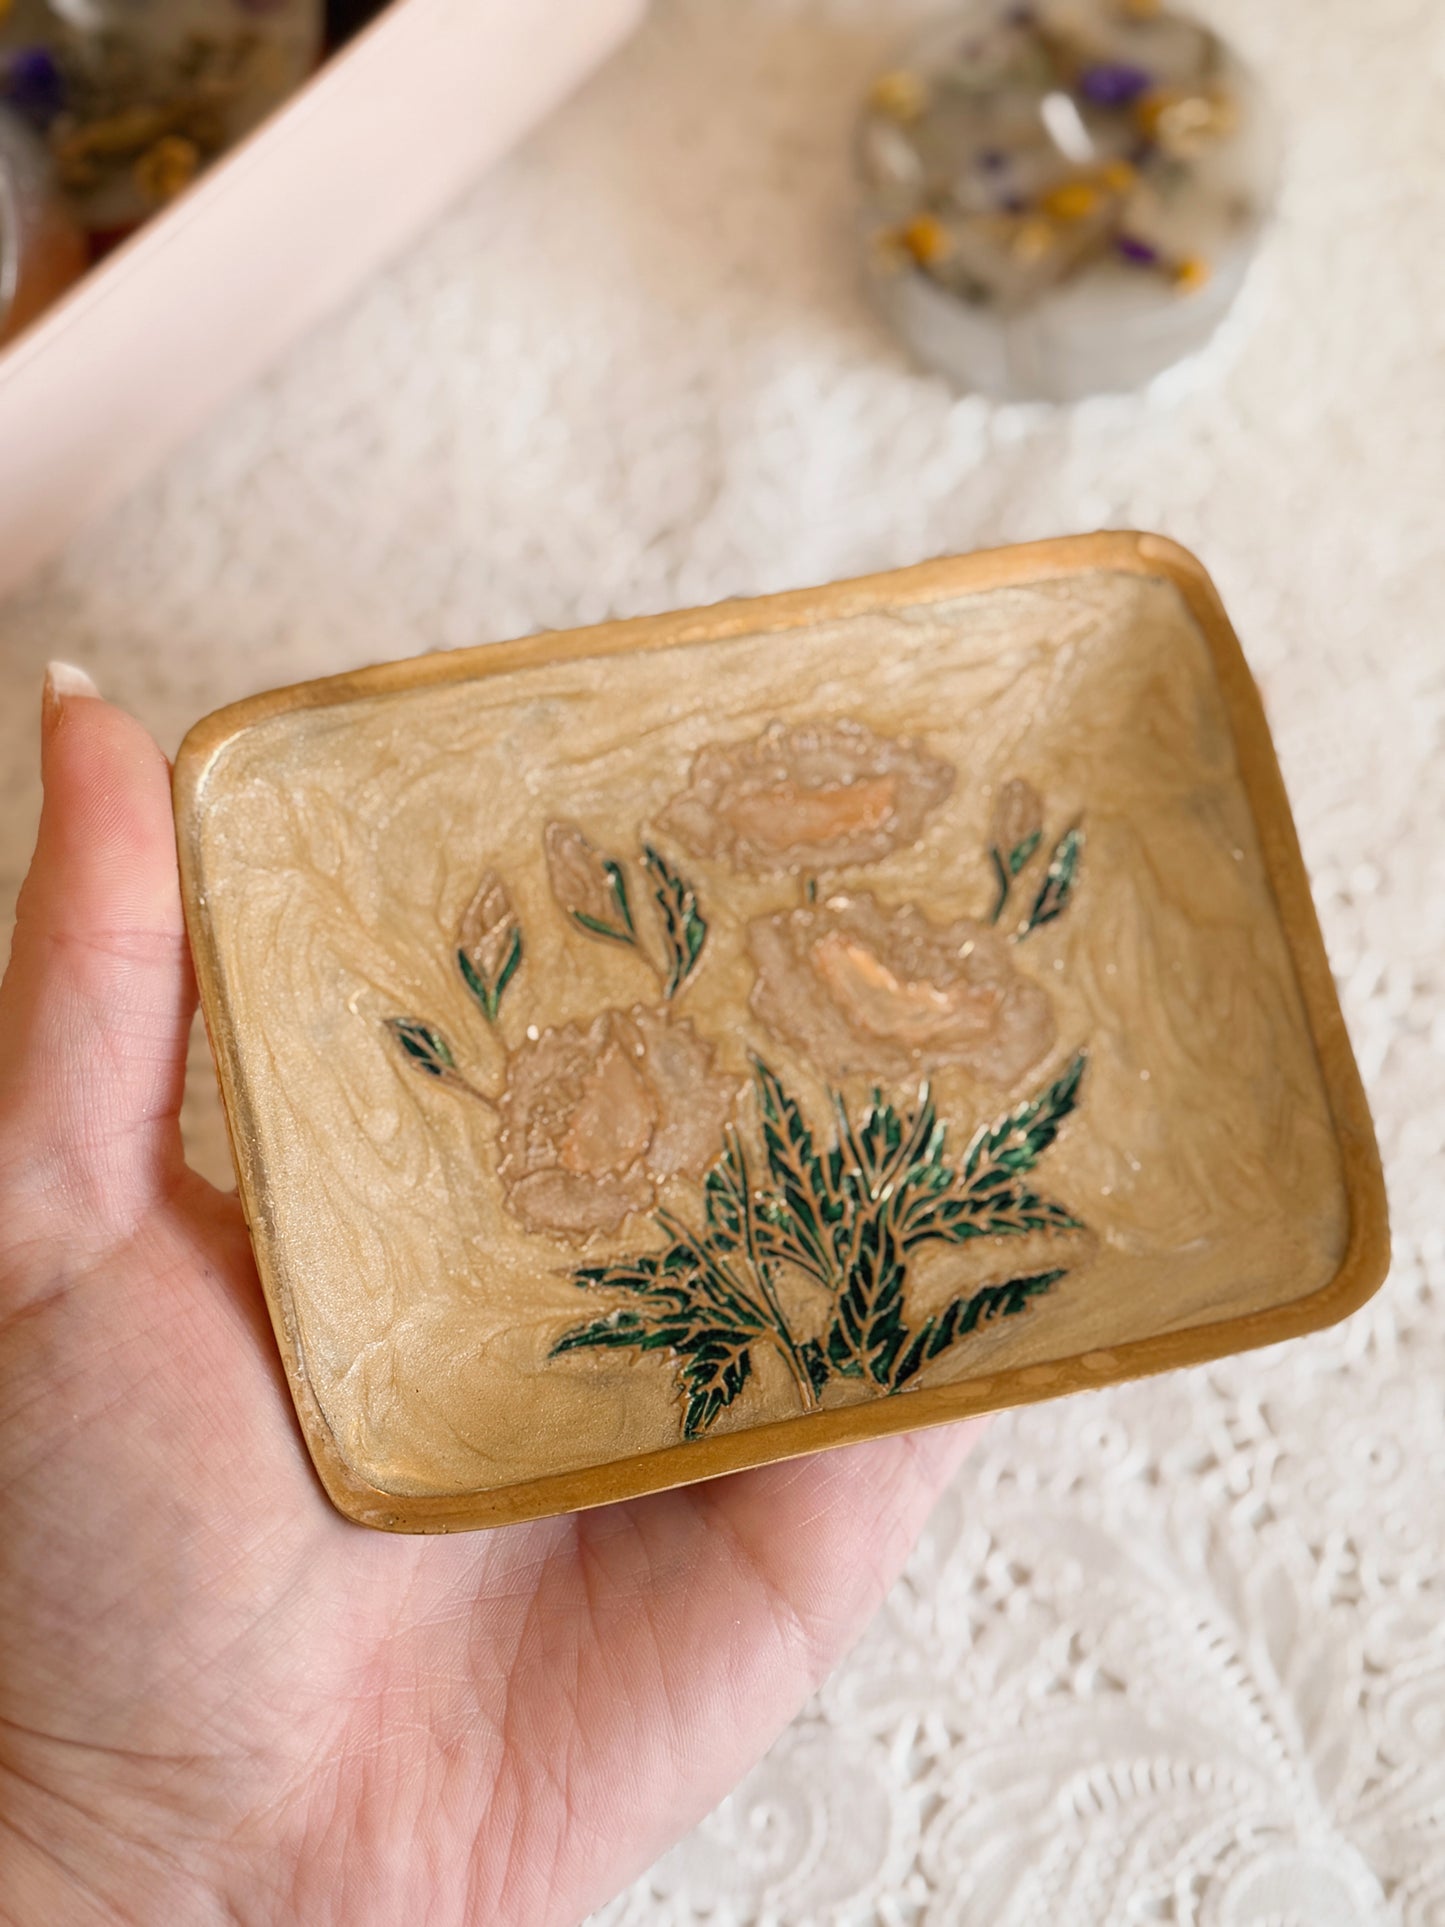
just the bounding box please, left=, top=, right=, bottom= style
left=748, top=896, right=1054, bottom=1085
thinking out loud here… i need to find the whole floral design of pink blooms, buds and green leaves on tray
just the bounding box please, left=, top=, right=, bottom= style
left=387, top=723, right=1085, bottom=1438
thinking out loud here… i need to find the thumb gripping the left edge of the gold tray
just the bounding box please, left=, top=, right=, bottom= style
left=0, top=663, right=195, bottom=1227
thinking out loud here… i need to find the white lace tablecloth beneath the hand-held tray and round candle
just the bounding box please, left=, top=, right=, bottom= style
left=0, top=0, right=1445, bottom=1927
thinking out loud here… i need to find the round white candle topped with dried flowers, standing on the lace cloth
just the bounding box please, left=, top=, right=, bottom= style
left=859, top=0, right=1274, bottom=401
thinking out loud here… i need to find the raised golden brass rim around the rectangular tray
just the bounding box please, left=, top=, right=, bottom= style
left=173, top=532, right=1389, bottom=1532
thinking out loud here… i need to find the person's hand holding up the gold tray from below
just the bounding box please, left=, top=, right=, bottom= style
left=0, top=671, right=967, bottom=1927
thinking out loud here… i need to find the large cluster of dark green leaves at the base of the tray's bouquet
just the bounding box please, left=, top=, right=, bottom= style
left=555, top=1054, right=1085, bottom=1438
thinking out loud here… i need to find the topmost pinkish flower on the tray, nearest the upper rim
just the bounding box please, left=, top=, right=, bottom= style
left=661, top=723, right=954, bottom=877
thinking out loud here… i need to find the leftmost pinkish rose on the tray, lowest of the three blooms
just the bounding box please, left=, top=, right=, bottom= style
left=499, top=1006, right=738, bottom=1237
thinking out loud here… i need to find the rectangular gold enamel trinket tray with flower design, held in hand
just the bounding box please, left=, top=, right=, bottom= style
left=175, top=536, right=1387, bottom=1532
